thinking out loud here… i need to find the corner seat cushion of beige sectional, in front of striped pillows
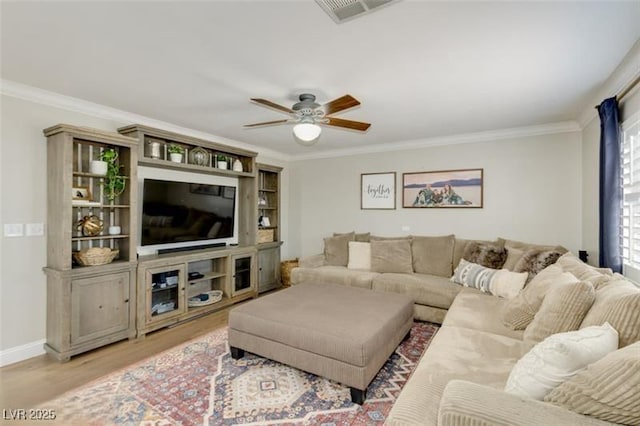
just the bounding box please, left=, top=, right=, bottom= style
left=442, top=288, right=524, bottom=340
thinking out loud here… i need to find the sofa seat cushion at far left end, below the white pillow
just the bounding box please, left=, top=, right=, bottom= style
left=291, top=265, right=379, bottom=289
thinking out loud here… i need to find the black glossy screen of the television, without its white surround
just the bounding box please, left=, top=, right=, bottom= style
left=141, top=179, right=236, bottom=246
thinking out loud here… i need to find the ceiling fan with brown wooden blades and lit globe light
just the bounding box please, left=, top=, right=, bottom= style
left=244, top=93, right=371, bottom=146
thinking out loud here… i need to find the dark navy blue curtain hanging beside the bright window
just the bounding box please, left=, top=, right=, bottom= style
left=598, top=97, right=622, bottom=273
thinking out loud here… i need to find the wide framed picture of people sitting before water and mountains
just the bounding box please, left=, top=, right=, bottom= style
left=402, top=169, right=484, bottom=208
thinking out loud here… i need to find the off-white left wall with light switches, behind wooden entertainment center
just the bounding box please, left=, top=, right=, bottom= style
left=0, top=95, right=289, bottom=365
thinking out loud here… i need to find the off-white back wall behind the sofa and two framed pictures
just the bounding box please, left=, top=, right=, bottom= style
left=289, top=132, right=582, bottom=256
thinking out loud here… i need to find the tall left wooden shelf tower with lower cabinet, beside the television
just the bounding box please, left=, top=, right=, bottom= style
left=44, top=124, right=138, bottom=361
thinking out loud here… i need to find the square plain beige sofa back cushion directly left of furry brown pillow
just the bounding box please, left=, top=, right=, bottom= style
left=411, top=235, right=455, bottom=278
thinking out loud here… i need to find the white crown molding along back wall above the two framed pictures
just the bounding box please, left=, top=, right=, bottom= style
left=292, top=121, right=582, bottom=161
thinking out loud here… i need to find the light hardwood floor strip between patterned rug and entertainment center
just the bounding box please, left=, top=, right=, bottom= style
left=0, top=307, right=231, bottom=412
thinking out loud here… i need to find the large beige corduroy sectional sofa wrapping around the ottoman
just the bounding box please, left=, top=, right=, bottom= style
left=291, top=234, right=640, bottom=426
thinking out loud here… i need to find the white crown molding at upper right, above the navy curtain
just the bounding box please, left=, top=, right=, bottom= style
left=577, top=39, right=640, bottom=129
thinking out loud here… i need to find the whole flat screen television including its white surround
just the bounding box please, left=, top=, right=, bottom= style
left=138, top=170, right=237, bottom=254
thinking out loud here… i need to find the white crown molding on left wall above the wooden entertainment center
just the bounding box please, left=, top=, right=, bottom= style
left=0, top=79, right=291, bottom=161
